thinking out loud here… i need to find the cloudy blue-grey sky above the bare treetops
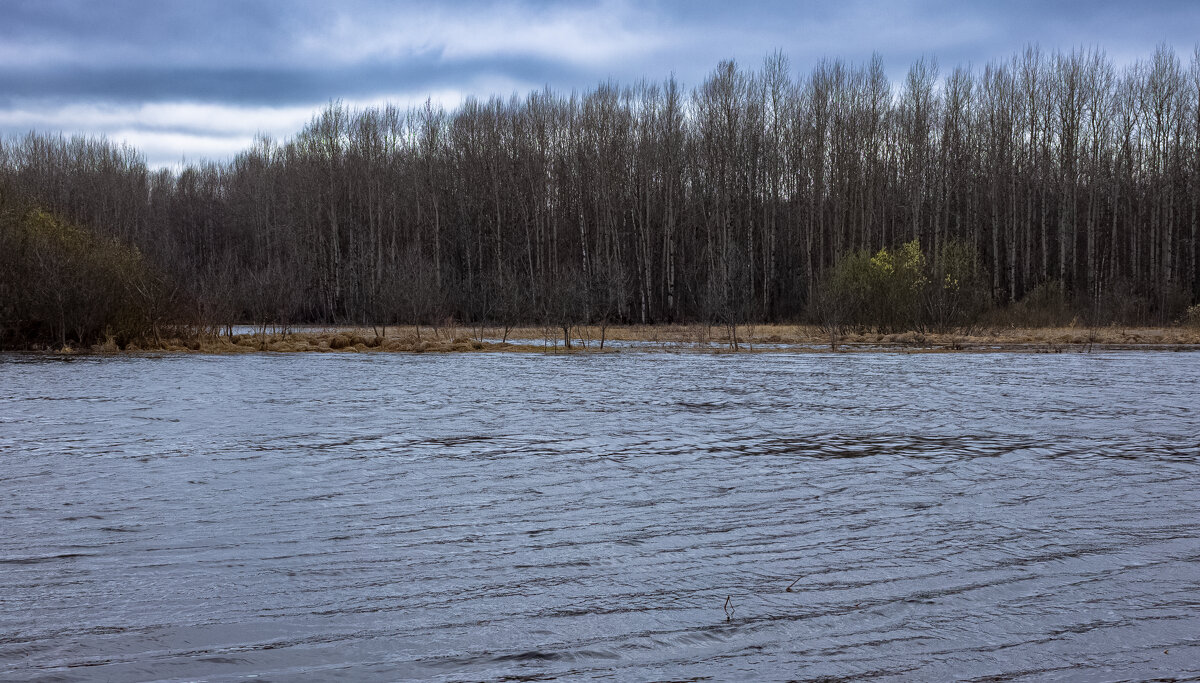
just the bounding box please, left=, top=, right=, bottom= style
left=0, top=0, right=1200, bottom=166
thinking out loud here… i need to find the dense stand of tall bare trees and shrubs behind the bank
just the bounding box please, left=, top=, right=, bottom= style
left=0, top=47, right=1200, bottom=343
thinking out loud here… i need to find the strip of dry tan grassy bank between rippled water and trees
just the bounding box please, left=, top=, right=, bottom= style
left=35, top=324, right=1200, bottom=354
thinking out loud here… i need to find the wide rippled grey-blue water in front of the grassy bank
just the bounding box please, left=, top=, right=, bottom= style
left=0, top=353, right=1200, bottom=681
